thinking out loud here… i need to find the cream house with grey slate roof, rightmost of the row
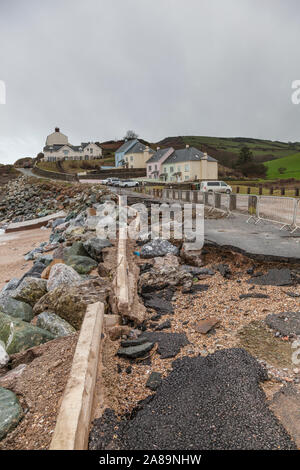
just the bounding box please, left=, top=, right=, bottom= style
left=160, top=145, right=218, bottom=182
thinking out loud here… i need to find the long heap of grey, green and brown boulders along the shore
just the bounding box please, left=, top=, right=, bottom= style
left=0, top=186, right=116, bottom=439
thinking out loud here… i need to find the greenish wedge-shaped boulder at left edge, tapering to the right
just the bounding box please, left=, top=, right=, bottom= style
left=0, top=312, right=54, bottom=354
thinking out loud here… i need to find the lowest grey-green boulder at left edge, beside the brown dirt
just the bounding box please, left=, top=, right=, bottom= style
left=0, top=387, right=23, bottom=440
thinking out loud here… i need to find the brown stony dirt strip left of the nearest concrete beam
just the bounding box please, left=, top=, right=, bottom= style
left=0, top=333, right=78, bottom=450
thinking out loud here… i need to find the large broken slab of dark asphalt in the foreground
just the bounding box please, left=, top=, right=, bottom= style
left=90, top=348, right=296, bottom=450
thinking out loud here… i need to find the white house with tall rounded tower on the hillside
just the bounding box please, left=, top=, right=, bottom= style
left=43, top=127, right=102, bottom=162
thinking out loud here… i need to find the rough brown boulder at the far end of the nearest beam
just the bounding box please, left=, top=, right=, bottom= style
left=33, top=279, right=111, bottom=330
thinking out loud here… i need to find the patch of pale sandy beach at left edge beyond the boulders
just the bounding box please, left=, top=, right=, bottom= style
left=0, top=228, right=51, bottom=289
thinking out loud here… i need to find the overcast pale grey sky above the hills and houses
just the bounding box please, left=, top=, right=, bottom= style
left=0, top=0, right=300, bottom=163
